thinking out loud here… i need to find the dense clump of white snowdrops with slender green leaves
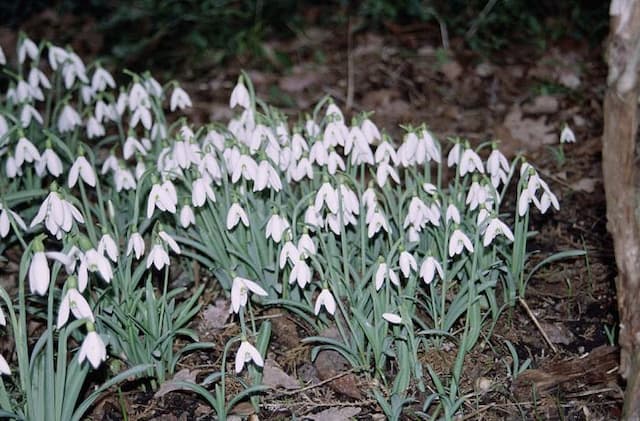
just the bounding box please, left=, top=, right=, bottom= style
left=0, top=36, right=559, bottom=420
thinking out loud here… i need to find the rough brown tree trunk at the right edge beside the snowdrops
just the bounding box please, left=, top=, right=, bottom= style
left=602, top=0, right=640, bottom=420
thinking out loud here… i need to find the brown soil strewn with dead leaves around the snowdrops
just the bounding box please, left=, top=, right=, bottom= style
left=7, top=7, right=621, bottom=421
